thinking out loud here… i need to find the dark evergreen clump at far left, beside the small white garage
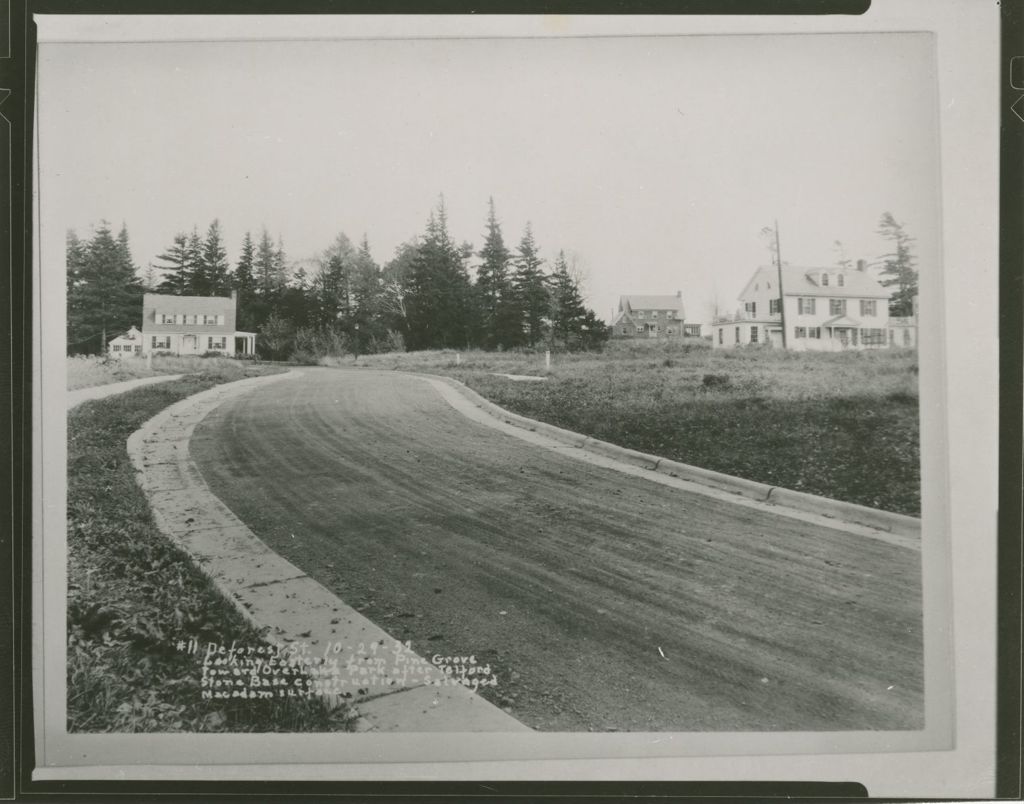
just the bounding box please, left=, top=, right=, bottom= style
left=68, top=221, right=142, bottom=353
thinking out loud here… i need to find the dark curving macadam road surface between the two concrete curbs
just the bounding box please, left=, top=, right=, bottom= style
left=191, top=370, right=923, bottom=731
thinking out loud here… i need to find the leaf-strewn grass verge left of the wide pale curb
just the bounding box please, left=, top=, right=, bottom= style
left=68, top=362, right=350, bottom=732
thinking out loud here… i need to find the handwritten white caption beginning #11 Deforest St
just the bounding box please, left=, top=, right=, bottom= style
left=184, top=640, right=498, bottom=700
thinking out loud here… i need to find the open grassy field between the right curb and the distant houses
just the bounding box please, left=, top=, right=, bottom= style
left=347, top=341, right=921, bottom=515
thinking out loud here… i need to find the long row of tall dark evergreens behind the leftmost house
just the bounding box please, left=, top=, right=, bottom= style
left=68, top=198, right=608, bottom=358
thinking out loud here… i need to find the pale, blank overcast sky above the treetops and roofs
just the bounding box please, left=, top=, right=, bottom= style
left=38, top=34, right=940, bottom=322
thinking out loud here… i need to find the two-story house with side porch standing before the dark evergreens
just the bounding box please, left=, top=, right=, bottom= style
left=142, top=291, right=256, bottom=356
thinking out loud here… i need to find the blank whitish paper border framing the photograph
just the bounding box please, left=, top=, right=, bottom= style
left=33, top=0, right=999, bottom=797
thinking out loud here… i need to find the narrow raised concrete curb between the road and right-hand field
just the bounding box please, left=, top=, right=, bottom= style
left=415, top=372, right=921, bottom=539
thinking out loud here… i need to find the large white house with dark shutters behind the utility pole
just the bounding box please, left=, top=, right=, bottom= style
left=712, top=260, right=903, bottom=350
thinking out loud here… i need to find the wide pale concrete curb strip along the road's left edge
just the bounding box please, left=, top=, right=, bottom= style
left=128, top=371, right=530, bottom=731
